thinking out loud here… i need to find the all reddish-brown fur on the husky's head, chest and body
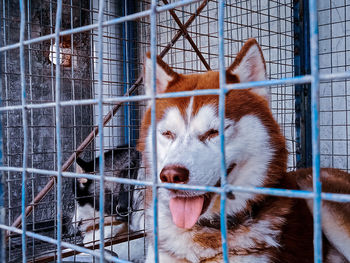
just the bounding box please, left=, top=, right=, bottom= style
left=138, top=40, right=350, bottom=263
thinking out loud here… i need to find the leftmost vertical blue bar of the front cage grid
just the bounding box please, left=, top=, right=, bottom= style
left=19, top=0, right=28, bottom=263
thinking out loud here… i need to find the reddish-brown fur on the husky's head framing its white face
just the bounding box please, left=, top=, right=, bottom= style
left=138, top=71, right=287, bottom=182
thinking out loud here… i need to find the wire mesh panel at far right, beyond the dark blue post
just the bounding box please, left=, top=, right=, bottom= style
left=318, top=1, right=350, bottom=170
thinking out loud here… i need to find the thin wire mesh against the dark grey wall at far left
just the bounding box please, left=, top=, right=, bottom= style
left=1, top=1, right=93, bottom=262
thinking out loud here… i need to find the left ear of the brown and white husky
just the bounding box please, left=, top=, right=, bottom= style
left=143, top=52, right=178, bottom=99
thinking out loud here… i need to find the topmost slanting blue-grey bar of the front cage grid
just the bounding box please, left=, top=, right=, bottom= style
left=0, top=0, right=201, bottom=52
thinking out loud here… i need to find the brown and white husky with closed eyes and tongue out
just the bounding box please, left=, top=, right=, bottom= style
left=138, top=39, right=350, bottom=263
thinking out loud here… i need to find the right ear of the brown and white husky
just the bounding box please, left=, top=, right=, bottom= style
left=227, top=38, right=269, bottom=100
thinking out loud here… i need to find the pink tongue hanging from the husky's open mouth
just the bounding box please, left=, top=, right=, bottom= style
left=169, top=196, right=204, bottom=229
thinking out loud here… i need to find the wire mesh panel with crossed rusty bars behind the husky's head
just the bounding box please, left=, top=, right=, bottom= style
left=140, top=1, right=295, bottom=169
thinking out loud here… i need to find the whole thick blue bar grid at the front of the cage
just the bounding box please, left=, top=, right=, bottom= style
left=0, top=0, right=350, bottom=263
